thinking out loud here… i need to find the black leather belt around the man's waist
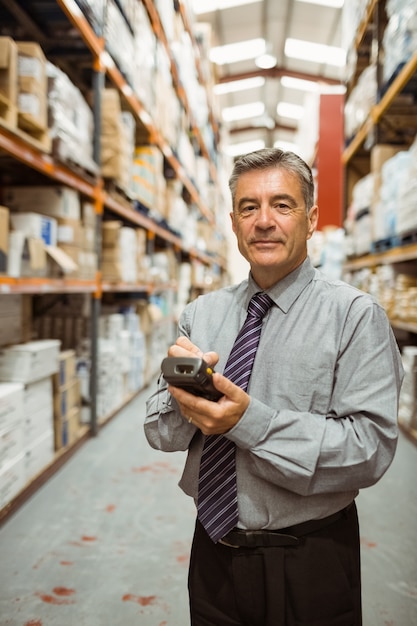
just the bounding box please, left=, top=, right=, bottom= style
left=219, top=503, right=353, bottom=548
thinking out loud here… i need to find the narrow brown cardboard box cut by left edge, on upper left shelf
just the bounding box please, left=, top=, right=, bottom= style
left=0, top=37, right=17, bottom=127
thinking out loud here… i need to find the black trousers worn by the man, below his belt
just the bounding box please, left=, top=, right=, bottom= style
left=188, top=505, right=362, bottom=626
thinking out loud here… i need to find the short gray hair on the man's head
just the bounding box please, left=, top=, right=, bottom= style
left=229, top=148, right=314, bottom=212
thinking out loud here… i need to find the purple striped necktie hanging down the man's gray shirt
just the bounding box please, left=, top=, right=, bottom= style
left=197, top=292, right=273, bottom=542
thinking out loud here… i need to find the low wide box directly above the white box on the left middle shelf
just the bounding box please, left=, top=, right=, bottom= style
left=3, top=186, right=81, bottom=220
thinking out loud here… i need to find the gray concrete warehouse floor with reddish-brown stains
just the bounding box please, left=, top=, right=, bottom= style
left=0, top=380, right=417, bottom=626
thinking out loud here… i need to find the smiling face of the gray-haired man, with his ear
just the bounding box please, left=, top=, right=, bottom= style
left=231, top=163, right=318, bottom=289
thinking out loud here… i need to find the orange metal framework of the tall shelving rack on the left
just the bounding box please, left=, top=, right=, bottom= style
left=0, top=0, right=226, bottom=521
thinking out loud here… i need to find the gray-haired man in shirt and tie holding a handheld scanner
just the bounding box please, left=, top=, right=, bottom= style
left=145, top=149, right=403, bottom=626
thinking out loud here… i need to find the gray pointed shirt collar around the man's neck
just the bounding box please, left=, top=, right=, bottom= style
left=246, top=257, right=315, bottom=313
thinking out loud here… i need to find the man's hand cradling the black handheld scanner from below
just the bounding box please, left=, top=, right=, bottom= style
left=168, top=370, right=250, bottom=435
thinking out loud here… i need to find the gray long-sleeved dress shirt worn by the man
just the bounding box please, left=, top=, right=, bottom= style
left=145, top=258, right=403, bottom=529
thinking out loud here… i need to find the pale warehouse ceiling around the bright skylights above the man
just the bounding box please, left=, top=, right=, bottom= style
left=194, top=0, right=344, bottom=156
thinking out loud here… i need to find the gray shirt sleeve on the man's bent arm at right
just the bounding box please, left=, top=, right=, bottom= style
left=228, top=303, right=403, bottom=495
